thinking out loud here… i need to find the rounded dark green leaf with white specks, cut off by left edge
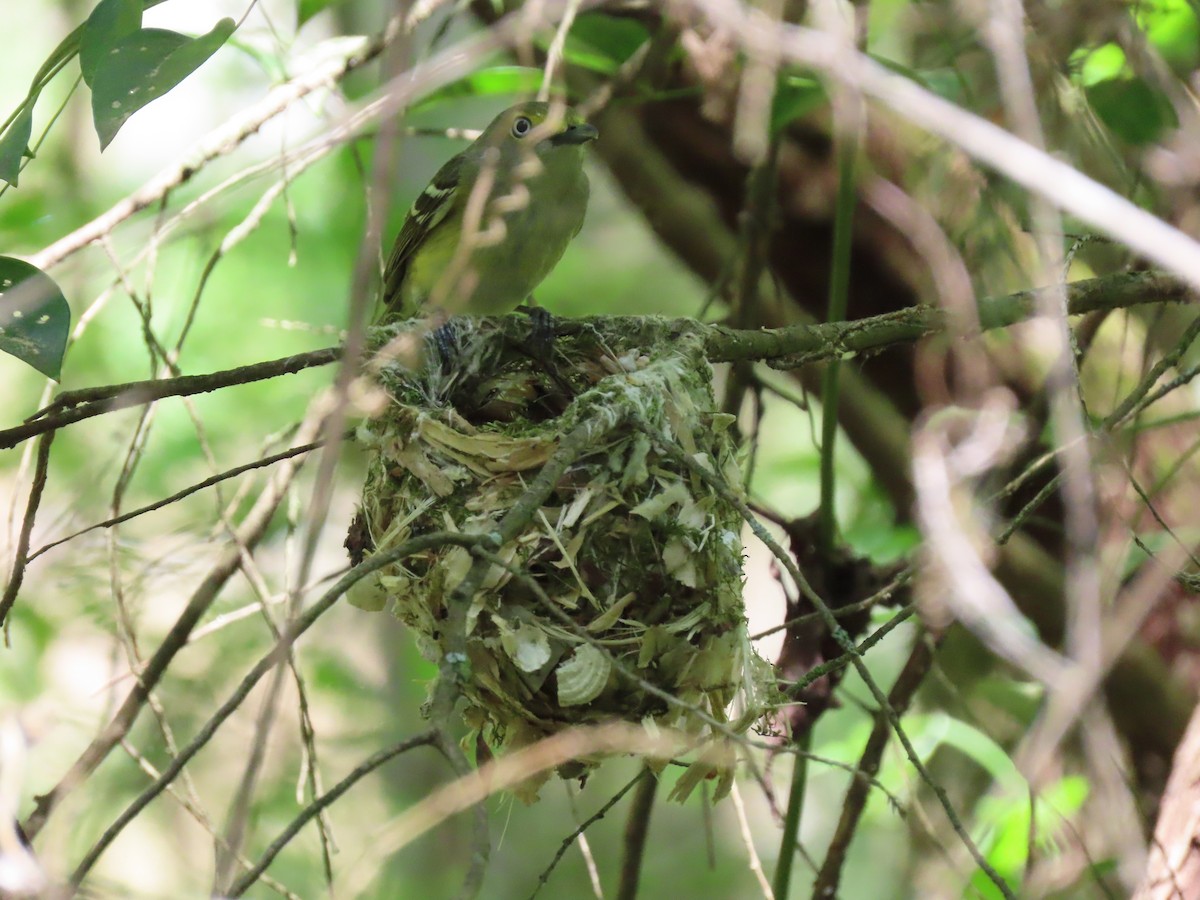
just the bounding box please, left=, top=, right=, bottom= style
left=0, top=257, right=71, bottom=380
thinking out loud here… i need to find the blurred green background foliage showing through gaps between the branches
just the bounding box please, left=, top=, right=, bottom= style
left=0, top=0, right=1200, bottom=900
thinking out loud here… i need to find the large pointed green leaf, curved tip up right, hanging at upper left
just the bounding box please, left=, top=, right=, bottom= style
left=91, top=19, right=236, bottom=150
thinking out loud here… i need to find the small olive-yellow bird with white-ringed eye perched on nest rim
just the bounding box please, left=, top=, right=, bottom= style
left=382, top=102, right=599, bottom=319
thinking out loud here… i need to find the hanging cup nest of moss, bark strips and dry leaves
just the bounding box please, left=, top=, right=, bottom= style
left=347, top=317, right=775, bottom=801
